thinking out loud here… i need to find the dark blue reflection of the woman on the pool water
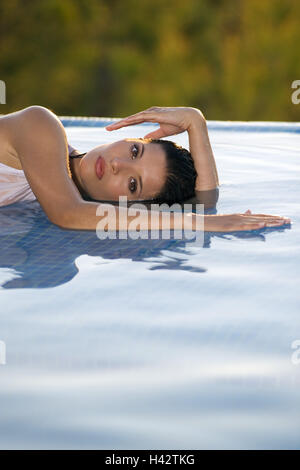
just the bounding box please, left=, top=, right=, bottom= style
left=0, top=201, right=284, bottom=289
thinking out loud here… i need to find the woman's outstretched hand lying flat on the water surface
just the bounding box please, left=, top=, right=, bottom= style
left=204, top=210, right=291, bottom=232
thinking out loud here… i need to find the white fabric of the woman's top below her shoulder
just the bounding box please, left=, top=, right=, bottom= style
left=0, top=163, right=36, bottom=207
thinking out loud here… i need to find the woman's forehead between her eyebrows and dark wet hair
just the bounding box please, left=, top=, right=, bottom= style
left=126, top=139, right=167, bottom=199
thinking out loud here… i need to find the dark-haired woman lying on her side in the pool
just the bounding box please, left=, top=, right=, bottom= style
left=0, top=106, right=290, bottom=232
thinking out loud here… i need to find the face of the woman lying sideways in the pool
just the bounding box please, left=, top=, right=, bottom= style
left=73, top=139, right=166, bottom=201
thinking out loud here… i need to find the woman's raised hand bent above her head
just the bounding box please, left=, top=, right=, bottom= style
left=105, top=106, right=204, bottom=139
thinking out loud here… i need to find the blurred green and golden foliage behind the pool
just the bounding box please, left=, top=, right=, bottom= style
left=0, top=0, right=300, bottom=121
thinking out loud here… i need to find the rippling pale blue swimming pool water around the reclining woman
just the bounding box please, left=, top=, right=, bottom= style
left=0, top=118, right=300, bottom=449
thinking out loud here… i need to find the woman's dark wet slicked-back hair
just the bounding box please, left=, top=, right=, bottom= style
left=81, top=139, right=197, bottom=205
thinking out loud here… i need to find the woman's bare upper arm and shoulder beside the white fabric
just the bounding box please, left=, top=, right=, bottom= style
left=2, top=106, right=82, bottom=225
